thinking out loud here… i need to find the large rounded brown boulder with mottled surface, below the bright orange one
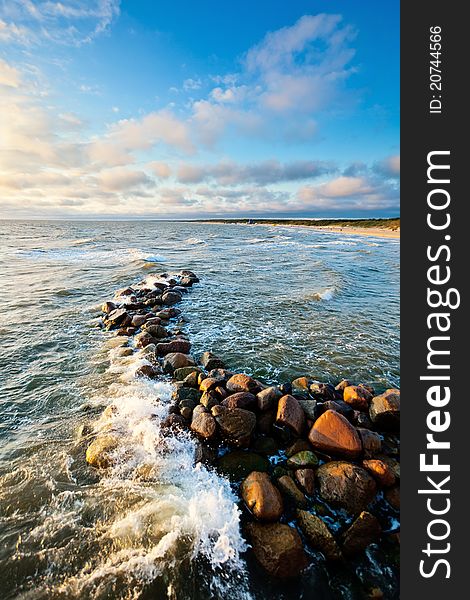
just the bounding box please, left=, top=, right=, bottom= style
left=316, top=461, right=377, bottom=514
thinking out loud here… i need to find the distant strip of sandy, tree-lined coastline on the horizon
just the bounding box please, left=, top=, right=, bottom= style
left=184, top=217, right=400, bottom=239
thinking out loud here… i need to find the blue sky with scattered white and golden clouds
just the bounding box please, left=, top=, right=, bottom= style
left=0, top=0, right=400, bottom=218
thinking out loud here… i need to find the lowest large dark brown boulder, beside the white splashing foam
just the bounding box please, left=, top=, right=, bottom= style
left=246, top=523, right=308, bottom=579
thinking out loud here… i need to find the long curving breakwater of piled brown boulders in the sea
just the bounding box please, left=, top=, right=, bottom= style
left=86, top=270, right=400, bottom=598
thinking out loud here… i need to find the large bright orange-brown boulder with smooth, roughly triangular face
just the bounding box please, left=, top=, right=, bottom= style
left=308, top=410, right=362, bottom=458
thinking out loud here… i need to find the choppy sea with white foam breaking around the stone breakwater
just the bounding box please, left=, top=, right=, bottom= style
left=0, top=222, right=399, bottom=599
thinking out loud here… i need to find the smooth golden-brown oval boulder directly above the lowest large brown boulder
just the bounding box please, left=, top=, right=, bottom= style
left=240, top=471, right=284, bottom=521
